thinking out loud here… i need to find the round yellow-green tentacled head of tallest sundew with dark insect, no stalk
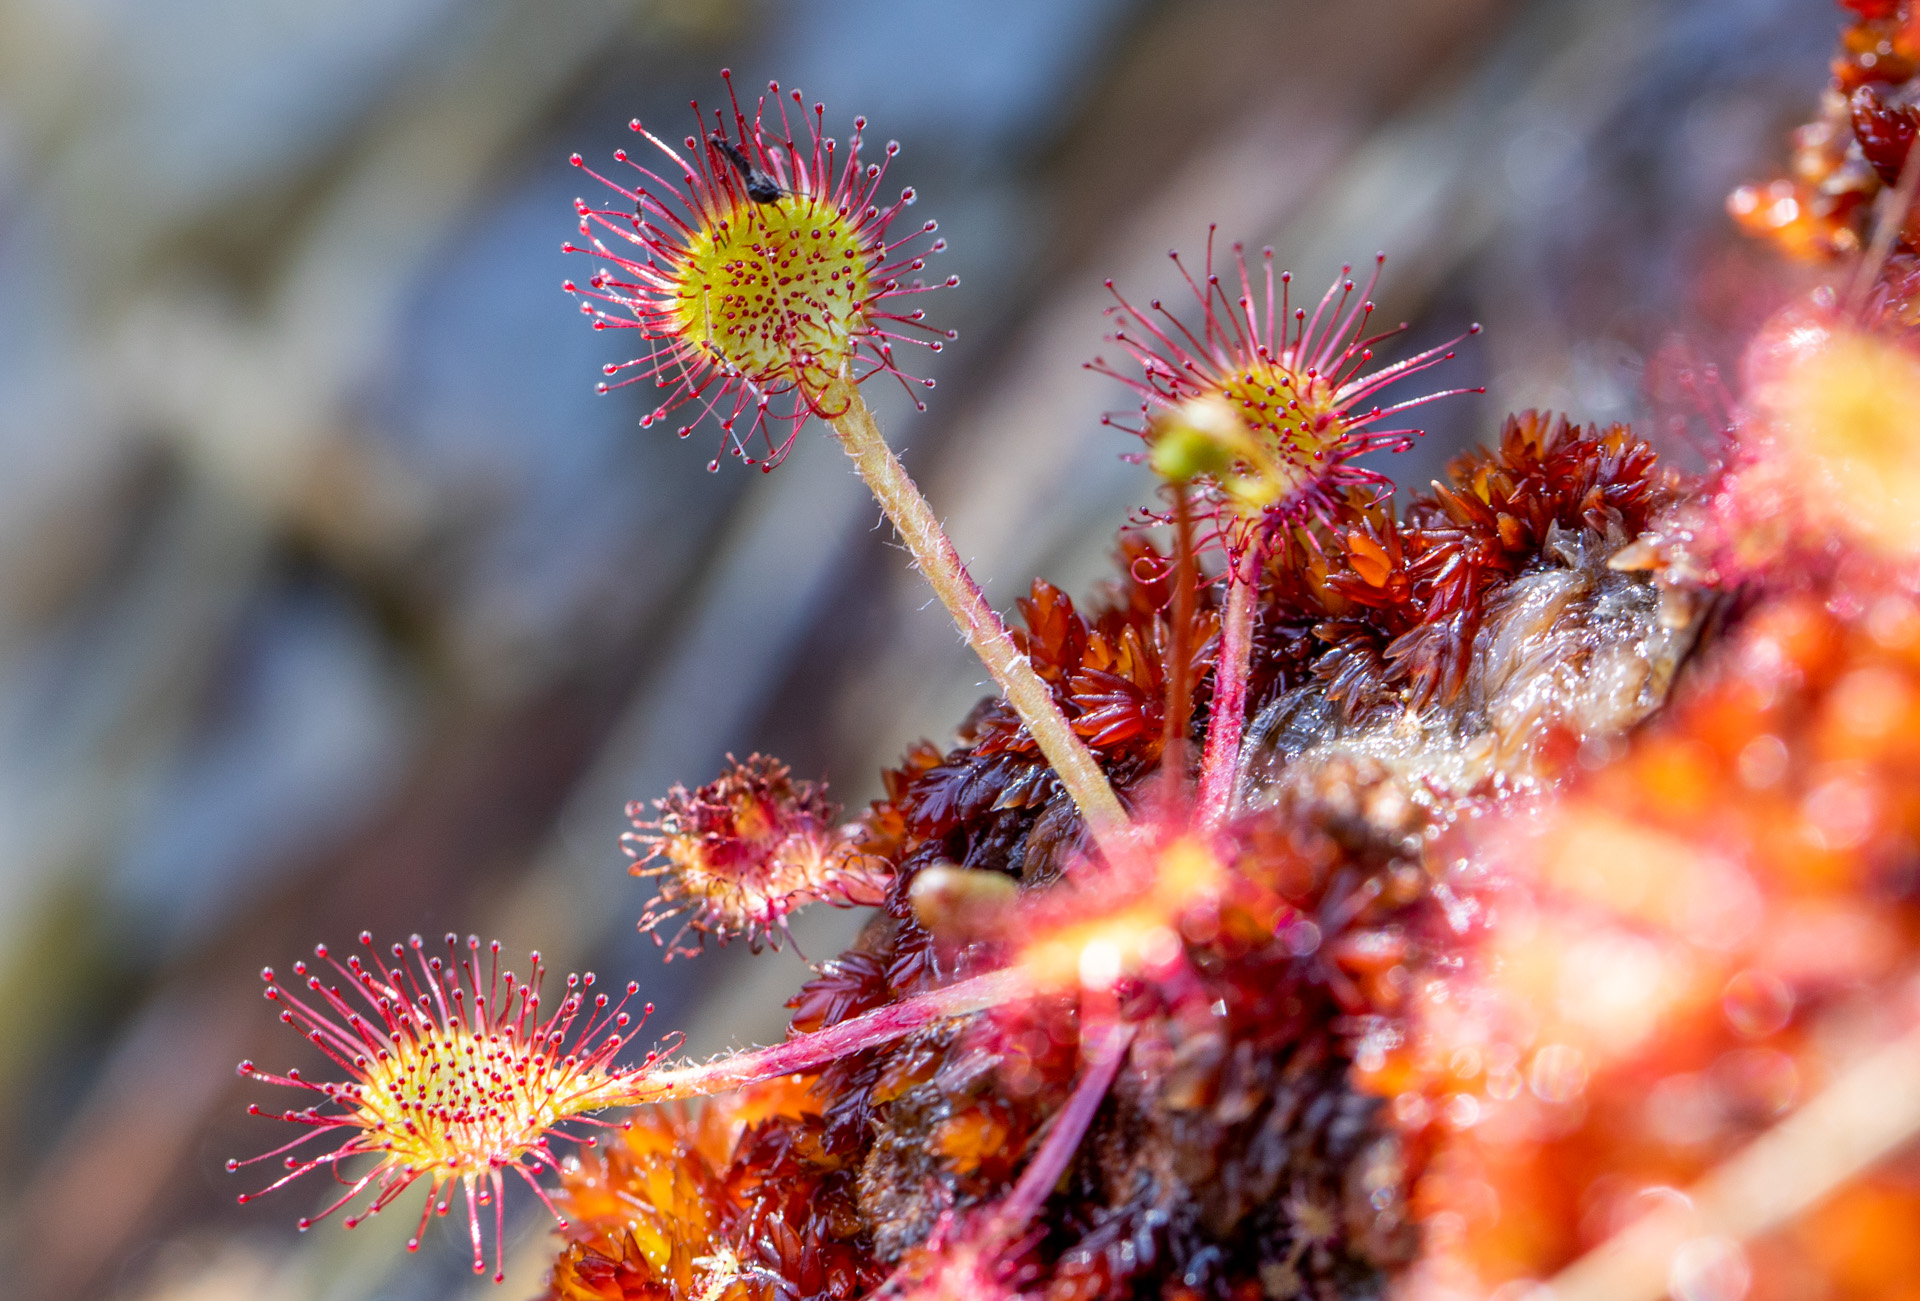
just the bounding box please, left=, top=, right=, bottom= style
left=566, top=71, right=960, bottom=470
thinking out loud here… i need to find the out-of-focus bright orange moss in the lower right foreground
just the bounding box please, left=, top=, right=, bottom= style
left=1413, top=578, right=1920, bottom=1297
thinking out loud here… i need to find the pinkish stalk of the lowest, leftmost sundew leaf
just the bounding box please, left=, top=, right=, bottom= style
left=618, top=971, right=1025, bottom=1107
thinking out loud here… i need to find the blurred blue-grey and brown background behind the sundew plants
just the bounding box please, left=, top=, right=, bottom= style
left=0, top=0, right=1837, bottom=1301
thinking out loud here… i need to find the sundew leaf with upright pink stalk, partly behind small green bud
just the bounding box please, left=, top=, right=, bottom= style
left=1089, top=230, right=1484, bottom=819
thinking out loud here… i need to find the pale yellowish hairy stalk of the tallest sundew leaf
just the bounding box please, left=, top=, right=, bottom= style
left=824, top=386, right=1127, bottom=862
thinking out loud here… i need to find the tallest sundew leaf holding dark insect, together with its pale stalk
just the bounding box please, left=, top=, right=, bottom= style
left=564, top=71, right=1127, bottom=848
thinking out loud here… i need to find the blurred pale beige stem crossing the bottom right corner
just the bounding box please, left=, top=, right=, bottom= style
left=1548, top=1030, right=1920, bottom=1301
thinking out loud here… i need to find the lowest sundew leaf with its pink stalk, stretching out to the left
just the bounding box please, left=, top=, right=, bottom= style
left=227, top=931, right=1018, bottom=1282
